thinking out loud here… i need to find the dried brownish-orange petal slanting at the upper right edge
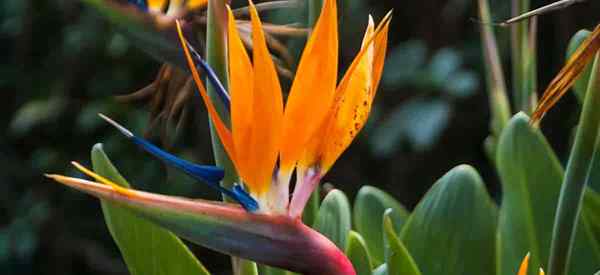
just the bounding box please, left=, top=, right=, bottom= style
left=531, top=24, right=600, bottom=124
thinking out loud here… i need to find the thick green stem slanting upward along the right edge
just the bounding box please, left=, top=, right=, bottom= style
left=548, top=55, right=600, bottom=275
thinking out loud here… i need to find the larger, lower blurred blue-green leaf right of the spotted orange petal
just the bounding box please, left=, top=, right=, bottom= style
left=369, top=98, right=450, bottom=157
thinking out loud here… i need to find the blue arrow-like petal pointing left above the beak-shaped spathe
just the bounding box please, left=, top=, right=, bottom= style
left=99, top=114, right=259, bottom=212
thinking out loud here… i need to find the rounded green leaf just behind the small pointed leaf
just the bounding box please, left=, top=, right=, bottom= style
left=354, top=185, right=408, bottom=265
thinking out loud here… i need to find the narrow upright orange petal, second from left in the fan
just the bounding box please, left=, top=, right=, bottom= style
left=227, top=7, right=254, bottom=188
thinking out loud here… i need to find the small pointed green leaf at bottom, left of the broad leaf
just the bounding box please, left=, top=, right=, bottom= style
left=382, top=209, right=421, bottom=275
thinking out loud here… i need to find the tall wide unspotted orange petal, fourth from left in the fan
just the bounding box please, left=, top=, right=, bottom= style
left=281, top=0, right=338, bottom=174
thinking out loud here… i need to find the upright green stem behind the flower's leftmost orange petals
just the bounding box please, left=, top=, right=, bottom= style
left=206, top=0, right=257, bottom=275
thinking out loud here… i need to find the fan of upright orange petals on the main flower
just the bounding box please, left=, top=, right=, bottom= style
left=180, top=0, right=391, bottom=217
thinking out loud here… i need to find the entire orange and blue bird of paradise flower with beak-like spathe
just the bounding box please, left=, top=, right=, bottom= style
left=47, top=0, right=391, bottom=274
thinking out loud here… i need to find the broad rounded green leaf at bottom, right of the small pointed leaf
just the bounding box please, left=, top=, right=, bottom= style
left=398, top=165, right=496, bottom=275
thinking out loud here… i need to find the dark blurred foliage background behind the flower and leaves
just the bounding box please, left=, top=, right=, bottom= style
left=0, top=0, right=600, bottom=275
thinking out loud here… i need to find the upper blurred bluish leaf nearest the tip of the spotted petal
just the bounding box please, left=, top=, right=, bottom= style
left=382, top=40, right=427, bottom=87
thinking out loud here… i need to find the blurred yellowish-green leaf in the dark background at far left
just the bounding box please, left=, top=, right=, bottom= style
left=9, top=96, right=67, bottom=137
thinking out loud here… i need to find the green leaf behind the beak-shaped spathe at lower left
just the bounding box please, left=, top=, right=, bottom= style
left=92, top=144, right=210, bottom=275
